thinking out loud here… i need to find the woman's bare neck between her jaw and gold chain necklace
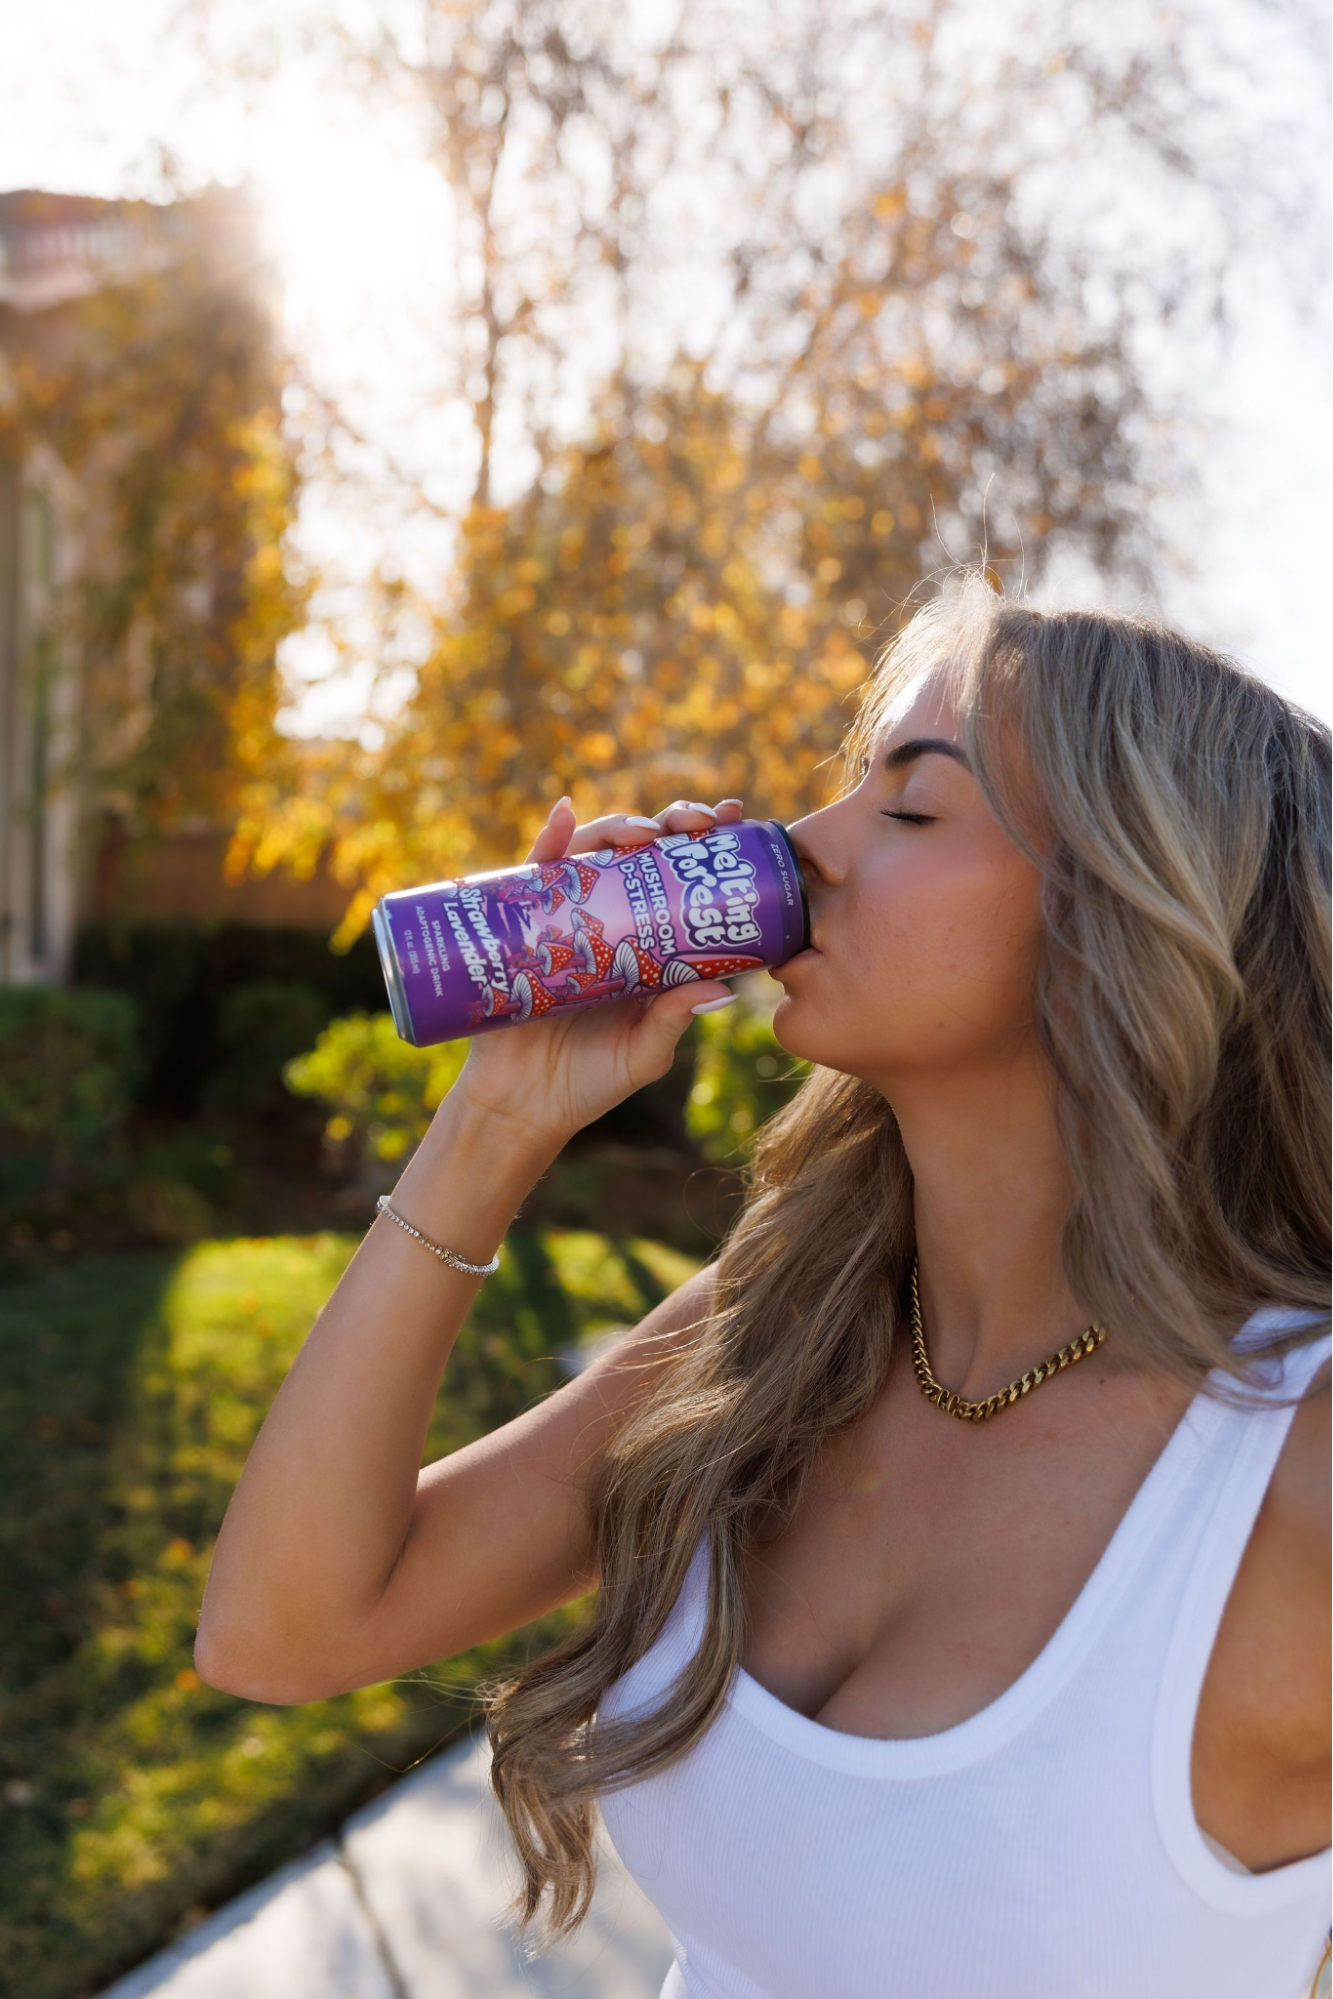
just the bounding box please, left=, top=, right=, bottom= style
left=885, top=1049, right=1109, bottom=1399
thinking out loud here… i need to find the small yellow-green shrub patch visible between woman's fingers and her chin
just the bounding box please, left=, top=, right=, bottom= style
left=685, top=974, right=811, bottom=1165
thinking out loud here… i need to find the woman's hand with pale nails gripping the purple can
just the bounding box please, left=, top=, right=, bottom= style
left=446, top=798, right=743, bottom=1147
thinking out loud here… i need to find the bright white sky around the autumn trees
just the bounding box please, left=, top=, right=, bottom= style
left=0, top=0, right=1333, bottom=732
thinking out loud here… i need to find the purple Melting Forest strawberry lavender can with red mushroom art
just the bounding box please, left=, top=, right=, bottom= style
left=372, top=820, right=809, bottom=1047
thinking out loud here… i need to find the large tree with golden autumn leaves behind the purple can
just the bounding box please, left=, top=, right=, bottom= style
left=213, top=0, right=1327, bottom=942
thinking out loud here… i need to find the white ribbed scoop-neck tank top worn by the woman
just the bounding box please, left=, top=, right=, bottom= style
left=598, top=1307, right=1333, bottom=1999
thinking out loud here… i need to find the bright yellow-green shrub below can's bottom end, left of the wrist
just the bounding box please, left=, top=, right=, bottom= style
left=282, top=1013, right=470, bottom=1193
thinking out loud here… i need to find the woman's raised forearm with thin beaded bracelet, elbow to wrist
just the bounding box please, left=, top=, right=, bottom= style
left=196, top=1095, right=560, bottom=1697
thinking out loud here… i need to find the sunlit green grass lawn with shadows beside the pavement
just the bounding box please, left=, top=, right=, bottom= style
left=0, top=1223, right=697, bottom=1999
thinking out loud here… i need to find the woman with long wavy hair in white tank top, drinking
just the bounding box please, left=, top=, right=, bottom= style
left=196, top=582, right=1331, bottom=1999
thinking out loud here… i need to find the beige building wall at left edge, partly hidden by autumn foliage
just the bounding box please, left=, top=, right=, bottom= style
left=0, top=190, right=323, bottom=984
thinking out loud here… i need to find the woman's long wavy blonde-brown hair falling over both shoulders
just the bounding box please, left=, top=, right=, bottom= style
left=480, top=576, right=1333, bottom=1955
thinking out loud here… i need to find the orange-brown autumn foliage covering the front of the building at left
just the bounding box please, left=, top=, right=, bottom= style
left=0, top=190, right=304, bottom=832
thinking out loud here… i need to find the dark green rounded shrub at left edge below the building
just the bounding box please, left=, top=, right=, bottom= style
left=0, top=986, right=142, bottom=1191
